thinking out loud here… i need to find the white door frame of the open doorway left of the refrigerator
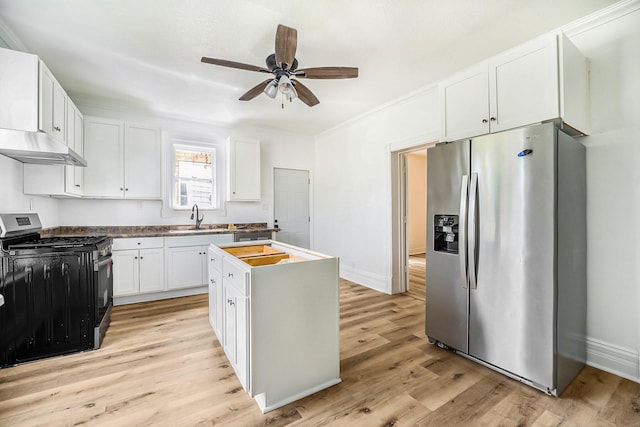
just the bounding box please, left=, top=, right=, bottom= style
left=391, top=141, right=437, bottom=294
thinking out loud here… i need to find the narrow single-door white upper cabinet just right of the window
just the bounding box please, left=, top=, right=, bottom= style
left=227, top=138, right=260, bottom=201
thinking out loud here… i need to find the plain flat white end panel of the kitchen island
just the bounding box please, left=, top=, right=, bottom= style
left=250, top=258, right=340, bottom=412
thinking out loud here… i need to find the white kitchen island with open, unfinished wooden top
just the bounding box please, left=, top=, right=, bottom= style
left=209, top=240, right=340, bottom=412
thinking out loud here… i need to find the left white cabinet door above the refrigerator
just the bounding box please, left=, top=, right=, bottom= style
left=438, top=63, right=490, bottom=141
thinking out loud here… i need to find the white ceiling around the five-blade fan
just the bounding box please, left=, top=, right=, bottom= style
left=0, top=0, right=615, bottom=135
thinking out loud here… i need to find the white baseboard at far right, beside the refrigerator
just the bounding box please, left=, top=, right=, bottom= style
left=587, top=338, right=640, bottom=383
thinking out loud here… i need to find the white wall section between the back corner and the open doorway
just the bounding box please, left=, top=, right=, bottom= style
left=313, top=87, right=438, bottom=293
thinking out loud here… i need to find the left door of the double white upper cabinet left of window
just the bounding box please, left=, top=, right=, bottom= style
left=84, top=117, right=124, bottom=198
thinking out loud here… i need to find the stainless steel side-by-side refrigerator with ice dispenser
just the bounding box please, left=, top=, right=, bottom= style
left=425, top=123, right=587, bottom=396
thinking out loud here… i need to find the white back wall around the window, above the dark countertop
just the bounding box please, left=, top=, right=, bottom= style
left=59, top=101, right=313, bottom=229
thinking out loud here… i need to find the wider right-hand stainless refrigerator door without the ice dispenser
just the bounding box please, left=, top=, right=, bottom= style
left=468, top=124, right=556, bottom=389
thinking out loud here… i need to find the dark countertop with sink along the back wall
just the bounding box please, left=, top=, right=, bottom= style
left=40, top=222, right=280, bottom=239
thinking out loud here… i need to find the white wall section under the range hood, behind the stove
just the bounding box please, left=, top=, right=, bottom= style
left=0, top=155, right=59, bottom=227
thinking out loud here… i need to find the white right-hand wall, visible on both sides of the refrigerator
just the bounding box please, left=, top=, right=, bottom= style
left=314, top=1, right=640, bottom=381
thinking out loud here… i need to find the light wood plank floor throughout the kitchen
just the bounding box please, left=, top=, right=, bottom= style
left=0, top=272, right=640, bottom=426
